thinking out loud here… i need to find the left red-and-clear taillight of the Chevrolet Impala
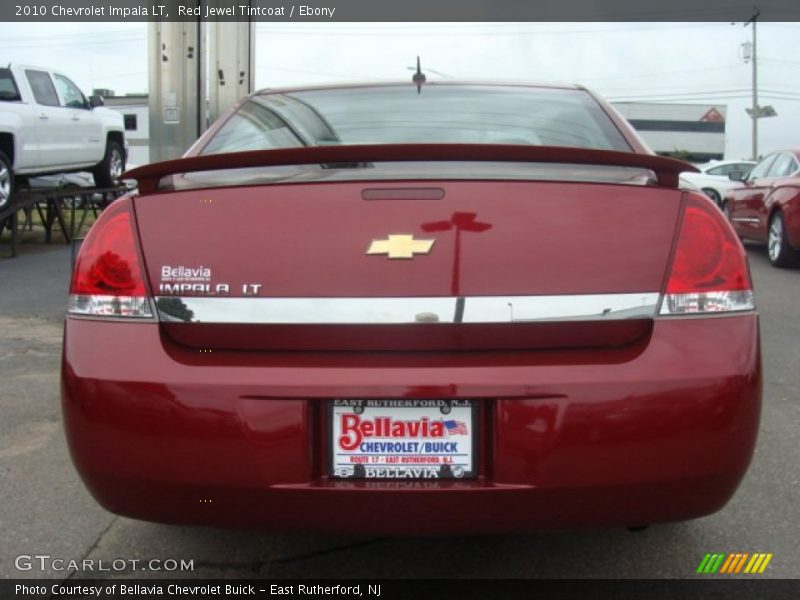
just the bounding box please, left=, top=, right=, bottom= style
left=68, top=198, right=153, bottom=319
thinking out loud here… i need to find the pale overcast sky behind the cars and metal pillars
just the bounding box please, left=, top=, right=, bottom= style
left=0, top=22, right=800, bottom=159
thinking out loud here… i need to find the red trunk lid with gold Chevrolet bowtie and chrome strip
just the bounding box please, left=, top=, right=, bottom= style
left=135, top=180, right=681, bottom=351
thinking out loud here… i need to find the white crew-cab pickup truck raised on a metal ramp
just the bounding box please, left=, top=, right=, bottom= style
left=0, top=65, right=127, bottom=210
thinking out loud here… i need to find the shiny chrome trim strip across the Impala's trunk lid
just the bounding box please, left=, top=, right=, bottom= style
left=156, top=292, right=660, bottom=325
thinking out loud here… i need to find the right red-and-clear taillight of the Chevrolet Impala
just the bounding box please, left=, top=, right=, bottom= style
left=661, top=194, right=755, bottom=315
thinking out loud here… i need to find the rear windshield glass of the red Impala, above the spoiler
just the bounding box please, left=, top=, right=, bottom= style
left=201, top=85, right=631, bottom=154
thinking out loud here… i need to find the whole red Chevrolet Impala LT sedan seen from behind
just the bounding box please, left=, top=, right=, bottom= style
left=62, top=83, right=761, bottom=534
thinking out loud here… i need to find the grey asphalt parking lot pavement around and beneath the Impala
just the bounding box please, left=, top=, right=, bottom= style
left=0, top=240, right=800, bottom=579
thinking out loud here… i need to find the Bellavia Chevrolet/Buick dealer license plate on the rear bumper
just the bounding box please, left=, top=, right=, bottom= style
left=329, top=399, right=478, bottom=479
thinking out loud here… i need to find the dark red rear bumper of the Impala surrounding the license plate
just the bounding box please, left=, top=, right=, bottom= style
left=62, top=315, right=761, bottom=534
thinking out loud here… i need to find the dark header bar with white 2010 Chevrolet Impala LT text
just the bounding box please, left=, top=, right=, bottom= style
left=0, top=0, right=800, bottom=23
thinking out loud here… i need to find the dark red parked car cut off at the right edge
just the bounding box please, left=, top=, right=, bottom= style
left=722, top=150, right=800, bottom=267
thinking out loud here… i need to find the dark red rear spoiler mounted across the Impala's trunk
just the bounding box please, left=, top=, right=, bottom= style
left=123, top=144, right=697, bottom=194
